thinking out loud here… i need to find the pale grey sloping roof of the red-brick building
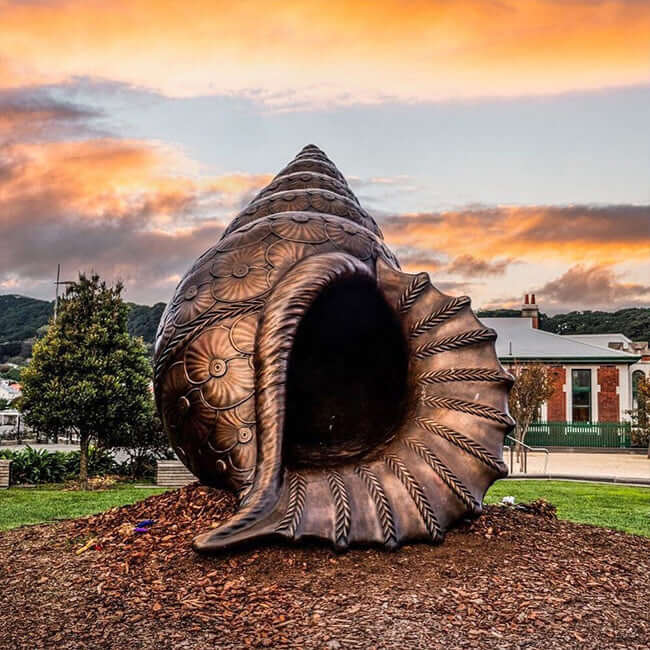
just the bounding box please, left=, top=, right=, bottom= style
left=481, top=318, right=640, bottom=363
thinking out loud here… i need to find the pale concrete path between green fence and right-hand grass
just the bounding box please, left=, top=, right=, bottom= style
left=504, top=452, right=650, bottom=480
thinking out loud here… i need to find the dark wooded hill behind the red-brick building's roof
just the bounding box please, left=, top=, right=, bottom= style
left=478, top=307, right=650, bottom=341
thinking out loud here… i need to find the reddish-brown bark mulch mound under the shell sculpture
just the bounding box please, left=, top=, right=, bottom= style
left=0, top=485, right=650, bottom=650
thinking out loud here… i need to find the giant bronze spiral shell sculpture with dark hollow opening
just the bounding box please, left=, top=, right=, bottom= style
left=154, top=145, right=513, bottom=553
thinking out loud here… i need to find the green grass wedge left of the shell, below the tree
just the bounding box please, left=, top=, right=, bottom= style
left=0, top=483, right=165, bottom=530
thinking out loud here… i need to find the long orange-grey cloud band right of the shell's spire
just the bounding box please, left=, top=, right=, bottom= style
left=382, top=205, right=650, bottom=263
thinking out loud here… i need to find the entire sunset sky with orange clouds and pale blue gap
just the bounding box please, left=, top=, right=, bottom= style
left=0, top=0, right=650, bottom=313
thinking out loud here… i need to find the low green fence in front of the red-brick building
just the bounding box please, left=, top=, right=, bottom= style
left=526, top=422, right=631, bottom=448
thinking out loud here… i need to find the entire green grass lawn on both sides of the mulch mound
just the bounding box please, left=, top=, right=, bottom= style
left=0, top=481, right=650, bottom=537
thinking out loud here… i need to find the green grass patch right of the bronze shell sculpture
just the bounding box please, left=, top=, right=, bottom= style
left=485, top=480, right=650, bottom=537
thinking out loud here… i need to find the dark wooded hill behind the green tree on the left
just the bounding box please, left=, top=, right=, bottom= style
left=0, top=295, right=165, bottom=363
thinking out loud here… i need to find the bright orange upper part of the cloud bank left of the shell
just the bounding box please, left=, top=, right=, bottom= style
left=0, top=138, right=271, bottom=225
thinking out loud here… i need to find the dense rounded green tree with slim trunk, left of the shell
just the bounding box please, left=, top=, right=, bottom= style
left=20, top=274, right=151, bottom=489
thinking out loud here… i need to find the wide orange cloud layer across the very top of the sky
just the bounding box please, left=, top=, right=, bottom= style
left=0, top=0, right=650, bottom=106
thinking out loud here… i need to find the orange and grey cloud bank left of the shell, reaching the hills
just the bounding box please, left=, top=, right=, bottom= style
left=0, top=139, right=271, bottom=299
